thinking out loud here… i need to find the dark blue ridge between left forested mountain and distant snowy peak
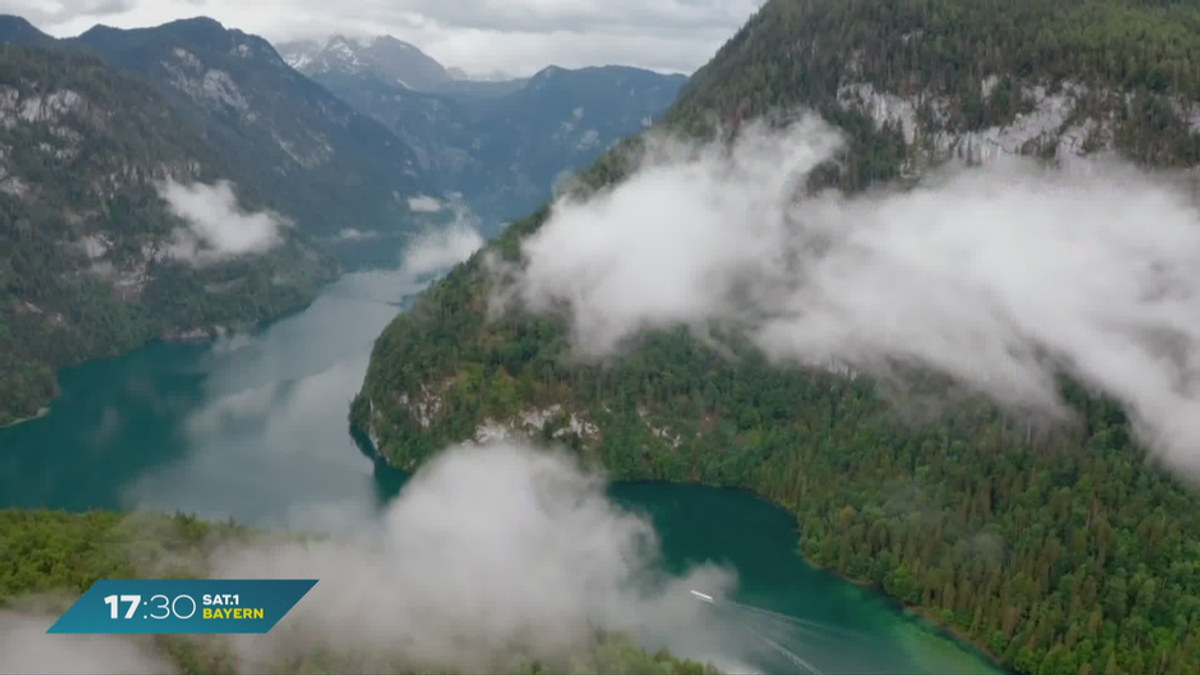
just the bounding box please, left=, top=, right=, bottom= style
left=0, top=18, right=437, bottom=247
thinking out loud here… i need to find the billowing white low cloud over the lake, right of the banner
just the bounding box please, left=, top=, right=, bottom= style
left=214, top=444, right=734, bottom=673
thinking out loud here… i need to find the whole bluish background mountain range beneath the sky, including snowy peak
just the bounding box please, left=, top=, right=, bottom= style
left=0, top=16, right=686, bottom=240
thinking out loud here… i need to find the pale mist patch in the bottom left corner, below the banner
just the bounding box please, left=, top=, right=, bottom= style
left=0, top=611, right=178, bottom=675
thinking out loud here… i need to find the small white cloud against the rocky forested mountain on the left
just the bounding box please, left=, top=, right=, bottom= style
left=158, top=179, right=282, bottom=263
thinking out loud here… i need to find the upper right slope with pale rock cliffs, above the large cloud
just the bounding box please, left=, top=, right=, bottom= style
left=671, top=0, right=1200, bottom=172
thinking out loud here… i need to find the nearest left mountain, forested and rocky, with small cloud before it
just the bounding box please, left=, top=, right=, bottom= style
left=0, top=44, right=336, bottom=424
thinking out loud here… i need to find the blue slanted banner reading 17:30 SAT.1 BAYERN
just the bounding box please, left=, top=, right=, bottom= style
left=47, top=579, right=317, bottom=633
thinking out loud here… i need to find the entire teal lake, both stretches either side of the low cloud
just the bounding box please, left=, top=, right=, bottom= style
left=0, top=265, right=1001, bottom=674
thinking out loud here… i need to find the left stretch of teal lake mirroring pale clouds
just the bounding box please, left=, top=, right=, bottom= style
left=0, top=265, right=416, bottom=527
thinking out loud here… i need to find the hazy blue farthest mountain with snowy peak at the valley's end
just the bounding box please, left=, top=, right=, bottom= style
left=280, top=36, right=686, bottom=225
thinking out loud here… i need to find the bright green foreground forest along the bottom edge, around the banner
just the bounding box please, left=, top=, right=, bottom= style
left=0, top=510, right=716, bottom=675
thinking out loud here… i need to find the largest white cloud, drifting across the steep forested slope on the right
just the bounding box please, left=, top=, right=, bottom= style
left=492, top=117, right=1200, bottom=470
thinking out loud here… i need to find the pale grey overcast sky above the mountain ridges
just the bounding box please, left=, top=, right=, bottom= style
left=0, top=0, right=762, bottom=76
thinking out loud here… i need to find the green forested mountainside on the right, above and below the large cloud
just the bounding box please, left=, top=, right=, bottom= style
left=350, top=0, right=1200, bottom=675
